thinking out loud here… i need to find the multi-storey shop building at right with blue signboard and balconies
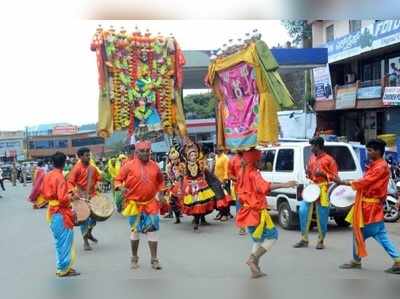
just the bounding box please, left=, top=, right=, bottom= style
left=312, top=20, right=400, bottom=143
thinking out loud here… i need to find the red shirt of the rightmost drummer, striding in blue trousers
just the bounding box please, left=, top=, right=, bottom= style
left=351, top=159, right=390, bottom=224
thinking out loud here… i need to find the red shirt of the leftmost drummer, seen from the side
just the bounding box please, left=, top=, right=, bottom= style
left=42, top=169, right=74, bottom=228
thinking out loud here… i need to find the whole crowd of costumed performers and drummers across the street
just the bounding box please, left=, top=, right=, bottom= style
left=18, top=137, right=400, bottom=278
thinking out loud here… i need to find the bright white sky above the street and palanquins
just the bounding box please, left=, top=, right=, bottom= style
left=0, top=18, right=290, bottom=130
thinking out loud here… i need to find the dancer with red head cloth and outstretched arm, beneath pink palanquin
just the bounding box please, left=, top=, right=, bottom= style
left=236, top=149, right=296, bottom=278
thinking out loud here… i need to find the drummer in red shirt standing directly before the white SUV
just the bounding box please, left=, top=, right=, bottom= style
left=293, top=137, right=338, bottom=249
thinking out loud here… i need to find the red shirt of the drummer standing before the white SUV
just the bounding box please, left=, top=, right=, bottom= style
left=307, top=153, right=338, bottom=184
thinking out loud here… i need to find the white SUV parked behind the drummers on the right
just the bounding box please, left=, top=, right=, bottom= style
left=259, top=140, right=362, bottom=229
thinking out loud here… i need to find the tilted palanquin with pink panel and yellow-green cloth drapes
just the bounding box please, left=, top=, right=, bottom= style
left=206, top=38, right=293, bottom=150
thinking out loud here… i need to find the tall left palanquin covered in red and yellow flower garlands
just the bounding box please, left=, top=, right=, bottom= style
left=91, top=27, right=186, bottom=138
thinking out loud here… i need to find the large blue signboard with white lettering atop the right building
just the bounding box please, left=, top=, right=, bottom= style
left=326, top=20, right=400, bottom=63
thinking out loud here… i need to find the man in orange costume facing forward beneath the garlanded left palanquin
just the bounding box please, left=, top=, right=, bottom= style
left=115, top=141, right=164, bottom=270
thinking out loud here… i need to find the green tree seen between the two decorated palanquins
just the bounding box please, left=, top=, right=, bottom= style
left=183, top=92, right=215, bottom=119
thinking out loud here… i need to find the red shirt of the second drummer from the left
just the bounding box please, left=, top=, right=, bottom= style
left=68, top=161, right=101, bottom=196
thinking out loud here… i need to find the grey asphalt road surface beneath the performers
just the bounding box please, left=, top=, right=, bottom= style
left=0, top=184, right=400, bottom=299
